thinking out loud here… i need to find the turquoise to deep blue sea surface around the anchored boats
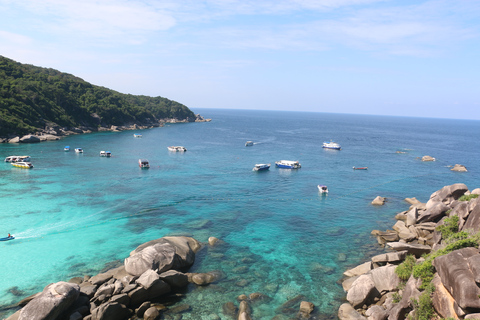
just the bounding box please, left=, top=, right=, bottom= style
left=0, top=109, right=480, bottom=319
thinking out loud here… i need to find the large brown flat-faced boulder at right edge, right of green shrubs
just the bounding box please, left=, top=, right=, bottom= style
left=434, top=248, right=480, bottom=310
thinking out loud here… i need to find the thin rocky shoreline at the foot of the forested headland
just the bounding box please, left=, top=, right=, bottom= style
left=0, top=114, right=212, bottom=143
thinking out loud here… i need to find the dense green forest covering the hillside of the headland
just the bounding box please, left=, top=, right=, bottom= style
left=0, top=56, right=195, bottom=136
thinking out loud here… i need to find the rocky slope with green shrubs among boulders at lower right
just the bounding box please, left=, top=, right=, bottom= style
left=338, top=183, right=480, bottom=320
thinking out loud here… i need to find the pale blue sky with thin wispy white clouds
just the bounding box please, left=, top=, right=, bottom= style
left=0, top=0, right=480, bottom=120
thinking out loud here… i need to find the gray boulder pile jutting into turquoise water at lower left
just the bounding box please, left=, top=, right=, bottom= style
left=8, top=237, right=201, bottom=320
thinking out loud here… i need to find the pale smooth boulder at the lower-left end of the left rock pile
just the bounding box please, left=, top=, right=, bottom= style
left=18, top=281, right=80, bottom=320
